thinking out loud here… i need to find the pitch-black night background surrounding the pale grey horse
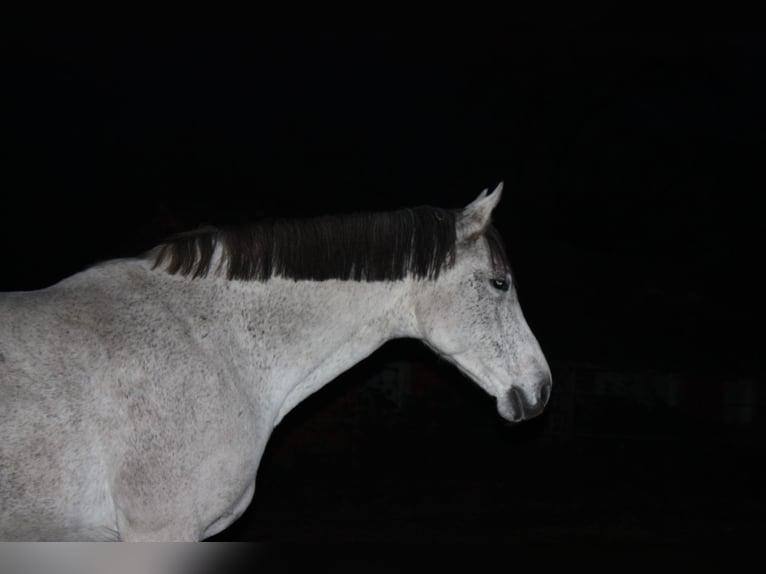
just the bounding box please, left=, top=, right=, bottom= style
left=0, top=14, right=766, bottom=560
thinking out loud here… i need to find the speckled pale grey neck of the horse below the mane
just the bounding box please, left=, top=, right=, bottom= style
left=237, top=279, right=415, bottom=425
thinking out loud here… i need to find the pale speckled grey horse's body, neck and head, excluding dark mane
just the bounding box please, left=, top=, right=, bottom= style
left=0, top=186, right=550, bottom=540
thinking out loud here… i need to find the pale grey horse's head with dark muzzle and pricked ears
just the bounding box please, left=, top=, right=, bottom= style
left=415, top=183, right=551, bottom=422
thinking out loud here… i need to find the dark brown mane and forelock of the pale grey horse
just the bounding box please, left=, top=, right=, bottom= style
left=154, top=207, right=506, bottom=281
